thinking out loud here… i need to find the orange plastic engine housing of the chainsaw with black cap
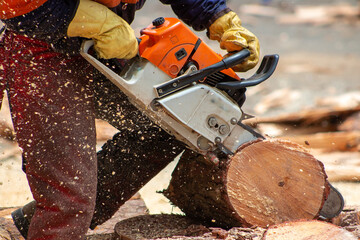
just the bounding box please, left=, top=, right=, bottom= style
left=139, top=18, right=240, bottom=80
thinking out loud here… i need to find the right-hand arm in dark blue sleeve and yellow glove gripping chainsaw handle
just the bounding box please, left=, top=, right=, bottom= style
left=160, top=0, right=260, bottom=72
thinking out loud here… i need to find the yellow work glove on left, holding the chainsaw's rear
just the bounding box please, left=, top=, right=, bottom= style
left=67, top=0, right=138, bottom=59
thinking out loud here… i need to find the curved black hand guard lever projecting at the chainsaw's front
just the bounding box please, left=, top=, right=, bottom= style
left=215, top=54, right=279, bottom=90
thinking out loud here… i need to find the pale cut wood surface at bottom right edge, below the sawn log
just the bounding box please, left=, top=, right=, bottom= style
left=263, top=220, right=357, bottom=240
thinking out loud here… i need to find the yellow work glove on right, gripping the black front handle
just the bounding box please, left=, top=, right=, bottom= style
left=208, top=11, right=260, bottom=72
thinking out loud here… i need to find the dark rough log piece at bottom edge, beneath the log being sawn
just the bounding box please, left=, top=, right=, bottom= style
left=114, top=214, right=265, bottom=240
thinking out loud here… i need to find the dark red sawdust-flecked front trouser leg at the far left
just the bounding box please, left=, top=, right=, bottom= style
left=0, top=31, right=97, bottom=240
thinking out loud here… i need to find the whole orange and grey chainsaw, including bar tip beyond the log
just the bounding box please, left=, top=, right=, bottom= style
left=81, top=17, right=344, bottom=218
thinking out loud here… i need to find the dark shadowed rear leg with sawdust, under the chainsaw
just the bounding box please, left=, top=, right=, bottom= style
left=91, top=71, right=185, bottom=229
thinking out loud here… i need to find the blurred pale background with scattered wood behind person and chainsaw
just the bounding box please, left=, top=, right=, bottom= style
left=0, top=0, right=360, bottom=216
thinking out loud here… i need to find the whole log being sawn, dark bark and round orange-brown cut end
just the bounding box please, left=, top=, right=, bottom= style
left=164, top=140, right=329, bottom=228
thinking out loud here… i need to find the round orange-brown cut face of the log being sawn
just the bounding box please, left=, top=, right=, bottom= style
left=226, top=140, right=329, bottom=227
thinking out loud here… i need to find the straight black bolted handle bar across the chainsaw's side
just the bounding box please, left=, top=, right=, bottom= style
left=155, top=49, right=250, bottom=98
